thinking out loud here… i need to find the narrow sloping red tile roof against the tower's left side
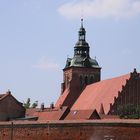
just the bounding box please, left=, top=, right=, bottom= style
left=55, top=89, right=69, bottom=107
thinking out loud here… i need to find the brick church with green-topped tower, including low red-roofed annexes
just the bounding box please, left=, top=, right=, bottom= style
left=26, top=19, right=140, bottom=120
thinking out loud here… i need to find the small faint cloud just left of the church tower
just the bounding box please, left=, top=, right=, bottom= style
left=33, top=56, right=60, bottom=70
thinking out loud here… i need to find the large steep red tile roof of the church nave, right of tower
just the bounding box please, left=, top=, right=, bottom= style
left=72, top=74, right=130, bottom=114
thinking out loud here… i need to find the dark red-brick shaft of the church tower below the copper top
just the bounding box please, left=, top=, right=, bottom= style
left=61, top=67, right=100, bottom=107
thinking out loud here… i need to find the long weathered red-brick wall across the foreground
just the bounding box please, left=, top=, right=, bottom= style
left=0, top=121, right=140, bottom=140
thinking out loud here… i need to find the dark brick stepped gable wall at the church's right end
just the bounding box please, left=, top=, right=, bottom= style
left=109, top=71, right=140, bottom=115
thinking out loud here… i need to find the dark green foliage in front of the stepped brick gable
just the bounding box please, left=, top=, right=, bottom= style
left=118, top=104, right=140, bottom=119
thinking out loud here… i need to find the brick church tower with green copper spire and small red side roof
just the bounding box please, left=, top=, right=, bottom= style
left=56, top=19, right=101, bottom=107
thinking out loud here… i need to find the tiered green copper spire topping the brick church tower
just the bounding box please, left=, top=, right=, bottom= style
left=65, top=19, right=99, bottom=68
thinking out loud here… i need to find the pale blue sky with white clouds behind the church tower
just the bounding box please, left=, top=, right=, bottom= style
left=0, top=0, right=140, bottom=105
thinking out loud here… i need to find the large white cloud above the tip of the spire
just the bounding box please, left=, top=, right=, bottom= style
left=58, top=0, right=140, bottom=19
